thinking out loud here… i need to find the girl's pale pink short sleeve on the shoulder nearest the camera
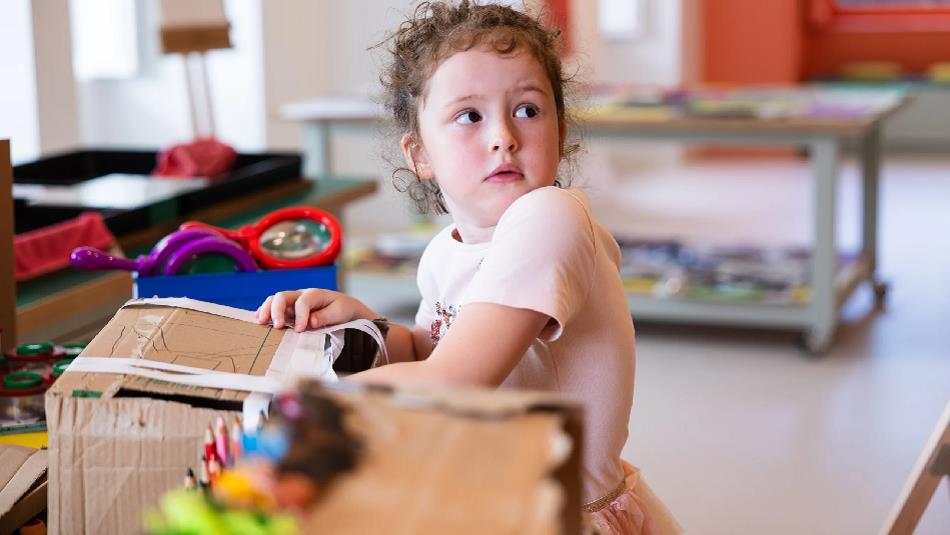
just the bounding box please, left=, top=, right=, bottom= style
left=463, top=187, right=595, bottom=341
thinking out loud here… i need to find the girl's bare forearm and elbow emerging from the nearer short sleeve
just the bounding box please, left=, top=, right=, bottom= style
left=347, top=303, right=550, bottom=387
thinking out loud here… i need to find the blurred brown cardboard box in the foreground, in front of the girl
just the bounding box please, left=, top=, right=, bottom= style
left=300, top=382, right=582, bottom=534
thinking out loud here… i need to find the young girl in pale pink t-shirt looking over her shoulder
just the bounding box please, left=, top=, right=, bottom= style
left=258, top=1, right=680, bottom=533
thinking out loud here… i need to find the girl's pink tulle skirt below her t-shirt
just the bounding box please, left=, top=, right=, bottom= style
left=590, top=462, right=683, bottom=535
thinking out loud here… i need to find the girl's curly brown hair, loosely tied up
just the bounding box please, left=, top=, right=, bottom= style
left=377, top=0, right=579, bottom=214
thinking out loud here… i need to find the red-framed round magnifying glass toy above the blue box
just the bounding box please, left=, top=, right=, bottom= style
left=180, top=206, right=343, bottom=269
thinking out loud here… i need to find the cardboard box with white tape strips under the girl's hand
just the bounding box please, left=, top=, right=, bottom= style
left=46, top=299, right=380, bottom=535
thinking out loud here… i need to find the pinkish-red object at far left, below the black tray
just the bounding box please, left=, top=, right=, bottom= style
left=13, top=212, right=115, bottom=282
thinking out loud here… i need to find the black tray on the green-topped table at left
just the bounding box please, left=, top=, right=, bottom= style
left=13, top=149, right=302, bottom=235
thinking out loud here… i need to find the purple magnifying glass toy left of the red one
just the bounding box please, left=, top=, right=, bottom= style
left=69, top=229, right=257, bottom=275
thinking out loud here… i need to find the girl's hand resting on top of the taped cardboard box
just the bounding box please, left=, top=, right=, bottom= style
left=257, top=288, right=378, bottom=333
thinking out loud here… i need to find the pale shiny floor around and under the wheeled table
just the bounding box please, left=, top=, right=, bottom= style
left=351, top=153, right=950, bottom=534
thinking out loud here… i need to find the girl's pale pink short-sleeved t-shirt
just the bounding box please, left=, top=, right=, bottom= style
left=416, top=187, right=636, bottom=501
